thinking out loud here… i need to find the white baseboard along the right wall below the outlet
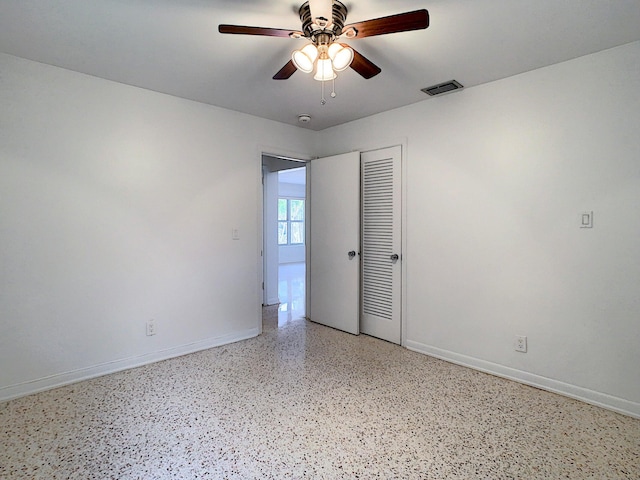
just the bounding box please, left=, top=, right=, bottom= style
left=405, top=340, right=640, bottom=418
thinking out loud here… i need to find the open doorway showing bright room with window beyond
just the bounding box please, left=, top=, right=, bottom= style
left=262, top=155, right=307, bottom=324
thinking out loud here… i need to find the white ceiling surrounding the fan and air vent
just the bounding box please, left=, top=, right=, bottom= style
left=0, top=0, right=640, bottom=130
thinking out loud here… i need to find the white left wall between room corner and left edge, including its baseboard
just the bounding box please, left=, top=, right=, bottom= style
left=0, top=55, right=317, bottom=400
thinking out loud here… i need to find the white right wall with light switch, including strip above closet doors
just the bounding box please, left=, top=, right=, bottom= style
left=319, top=43, right=640, bottom=416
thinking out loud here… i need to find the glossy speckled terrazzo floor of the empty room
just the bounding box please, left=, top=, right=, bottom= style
left=0, top=310, right=640, bottom=479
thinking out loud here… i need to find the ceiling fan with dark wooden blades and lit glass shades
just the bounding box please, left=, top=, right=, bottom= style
left=218, top=0, right=429, bottom=82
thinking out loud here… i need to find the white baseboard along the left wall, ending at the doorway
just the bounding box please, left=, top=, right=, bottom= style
left=0, top=328, right=260, bottom=402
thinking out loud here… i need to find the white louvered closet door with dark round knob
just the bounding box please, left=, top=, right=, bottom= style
left=360, top=146, right=402, bottom=344
